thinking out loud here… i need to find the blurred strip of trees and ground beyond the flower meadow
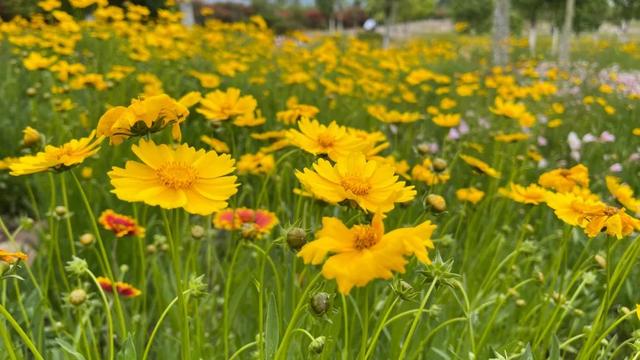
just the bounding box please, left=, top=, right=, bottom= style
left=0, top=0, right=640, bottom=37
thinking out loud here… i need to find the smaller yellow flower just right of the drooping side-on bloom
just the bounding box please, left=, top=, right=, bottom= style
left=196, top=88, right=258, bottom=121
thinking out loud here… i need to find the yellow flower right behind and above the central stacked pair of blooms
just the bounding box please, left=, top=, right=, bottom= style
left=287, top=118, right=367, bottom=161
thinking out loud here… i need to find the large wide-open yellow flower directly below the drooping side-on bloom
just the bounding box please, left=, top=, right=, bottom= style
left=109, top=140, right=238, bottom=215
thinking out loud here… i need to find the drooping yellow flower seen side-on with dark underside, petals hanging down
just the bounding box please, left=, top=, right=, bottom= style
left=97, top=94, right=189, bottom=145
